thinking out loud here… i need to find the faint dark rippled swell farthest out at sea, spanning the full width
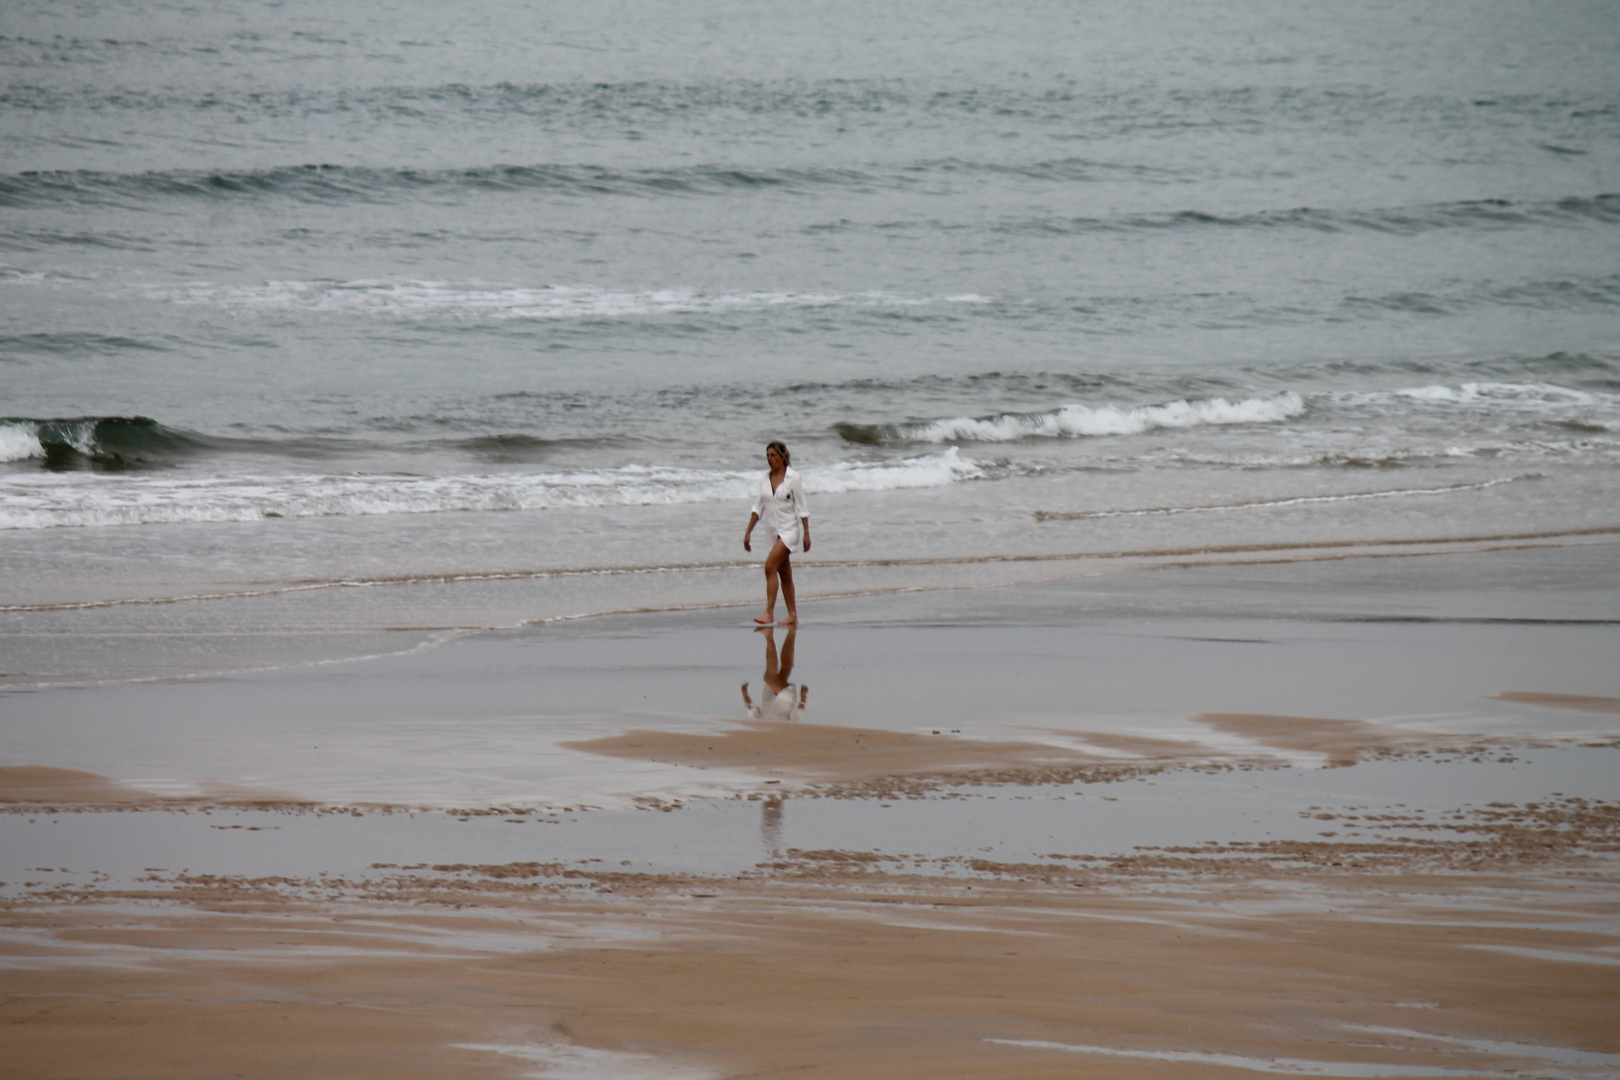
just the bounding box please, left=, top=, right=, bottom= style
left=9, top=76, right=1615, bottom=138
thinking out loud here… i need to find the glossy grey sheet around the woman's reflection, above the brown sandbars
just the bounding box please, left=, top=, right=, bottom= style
left=5, top=544, right=1620, bottom=806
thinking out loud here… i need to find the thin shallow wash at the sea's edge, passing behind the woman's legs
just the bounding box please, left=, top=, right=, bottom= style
left=0, top=526, right=1620, bottom=695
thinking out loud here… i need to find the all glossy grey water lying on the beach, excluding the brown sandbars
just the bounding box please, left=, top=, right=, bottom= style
left=0, top=546, right=1620, bottom=889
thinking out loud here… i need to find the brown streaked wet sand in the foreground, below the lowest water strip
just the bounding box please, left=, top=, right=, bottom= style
left=3, top=841, right=1620, bottom=1078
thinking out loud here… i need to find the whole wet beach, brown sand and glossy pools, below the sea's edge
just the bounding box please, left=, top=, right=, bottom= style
left=0, top=544, right=1620, bottom=1080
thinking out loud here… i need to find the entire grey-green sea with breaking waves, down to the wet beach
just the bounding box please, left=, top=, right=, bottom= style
left=0, top=0, right=1620, bottom=685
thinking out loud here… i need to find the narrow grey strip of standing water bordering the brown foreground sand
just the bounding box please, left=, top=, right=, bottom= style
left=0, top=746, right=1620, bottom=897
